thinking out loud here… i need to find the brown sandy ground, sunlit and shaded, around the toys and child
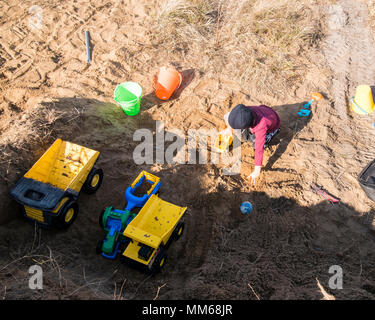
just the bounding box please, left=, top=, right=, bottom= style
left=0, top=0, right=375, bottom=299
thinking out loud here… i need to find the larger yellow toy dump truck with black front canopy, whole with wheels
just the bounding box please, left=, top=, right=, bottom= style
left=10, top=139, right=103, bottom=228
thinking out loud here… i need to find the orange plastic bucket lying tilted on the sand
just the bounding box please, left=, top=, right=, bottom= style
left=154, top=67, right=182, bottom=100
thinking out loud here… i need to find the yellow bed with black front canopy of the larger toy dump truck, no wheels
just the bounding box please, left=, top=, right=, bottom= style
left=10, top=139, right=99, bottom=210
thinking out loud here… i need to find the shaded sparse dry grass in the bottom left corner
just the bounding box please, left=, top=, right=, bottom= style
left=0, top=232, right=115, bottom=300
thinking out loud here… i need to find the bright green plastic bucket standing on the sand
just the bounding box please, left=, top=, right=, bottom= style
left=114, top=82, right=142, bottom=116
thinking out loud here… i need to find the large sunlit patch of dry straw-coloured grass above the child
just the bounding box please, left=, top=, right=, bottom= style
left=152, top=0, right=322, bottom=93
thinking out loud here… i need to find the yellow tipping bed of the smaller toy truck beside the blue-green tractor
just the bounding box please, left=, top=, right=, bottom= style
left=124, top=195, right=187, bottom=248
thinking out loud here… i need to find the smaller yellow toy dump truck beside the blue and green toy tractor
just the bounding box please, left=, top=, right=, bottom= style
left=121, top=195, right=187, bottom=272
